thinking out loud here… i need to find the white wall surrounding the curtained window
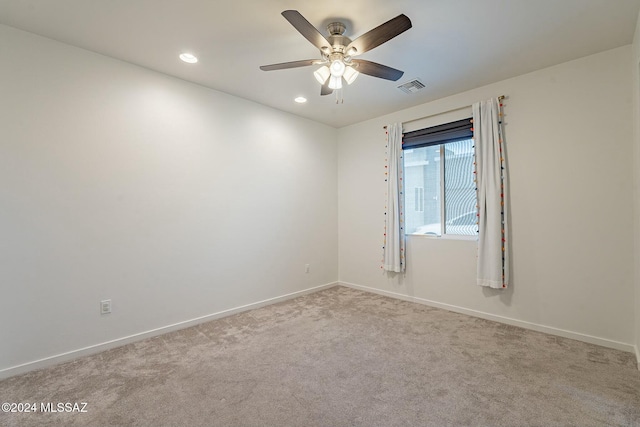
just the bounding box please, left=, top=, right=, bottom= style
left=338, top=46, right=636, bottom=351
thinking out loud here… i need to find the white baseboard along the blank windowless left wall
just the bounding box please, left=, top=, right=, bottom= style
left=0, top=282, right=338, bottom=379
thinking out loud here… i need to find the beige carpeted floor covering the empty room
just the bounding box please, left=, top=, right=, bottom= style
left=0, top=287, right=640, bottom=426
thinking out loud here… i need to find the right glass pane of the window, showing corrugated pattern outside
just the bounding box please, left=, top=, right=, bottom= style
left=443, top=139, right=477, bottom=236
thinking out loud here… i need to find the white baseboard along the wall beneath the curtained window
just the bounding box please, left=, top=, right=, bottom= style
left=338, top=282, right=640, bottom=354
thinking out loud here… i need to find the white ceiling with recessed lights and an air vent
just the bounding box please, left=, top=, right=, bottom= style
left=0, top=0, right=640, bottom=127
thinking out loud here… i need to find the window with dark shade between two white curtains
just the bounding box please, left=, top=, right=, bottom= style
left=402, top=119, right=477, bottom=236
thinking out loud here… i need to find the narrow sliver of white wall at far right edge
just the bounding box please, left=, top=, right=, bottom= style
left=631, top=8, right=640, bottom=369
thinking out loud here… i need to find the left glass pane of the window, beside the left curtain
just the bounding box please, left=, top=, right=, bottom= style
left=403, top=145, right=442, bottom=235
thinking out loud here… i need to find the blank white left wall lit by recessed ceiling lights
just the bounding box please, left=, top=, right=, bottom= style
left=0, top=26, right=338, bottom=375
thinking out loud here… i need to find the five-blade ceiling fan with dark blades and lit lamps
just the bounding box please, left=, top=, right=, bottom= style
left=260, top=10, right=411, bottom=95
